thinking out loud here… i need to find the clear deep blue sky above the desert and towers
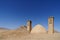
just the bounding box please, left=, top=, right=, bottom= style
left=0, top=0, right=60, bottom=31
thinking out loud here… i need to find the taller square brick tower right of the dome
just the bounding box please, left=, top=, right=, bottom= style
left=48, top=16, right=54, bottom=34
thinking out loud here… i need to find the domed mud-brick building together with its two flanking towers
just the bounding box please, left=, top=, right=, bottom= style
left=18, top=17, right=54, bottom=34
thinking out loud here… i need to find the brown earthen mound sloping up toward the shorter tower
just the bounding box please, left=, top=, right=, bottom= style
left=0, top=26, right=29, bottom=39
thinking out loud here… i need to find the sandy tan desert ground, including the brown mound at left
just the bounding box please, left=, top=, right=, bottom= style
left=0, top=27, right=60, bottom=40
